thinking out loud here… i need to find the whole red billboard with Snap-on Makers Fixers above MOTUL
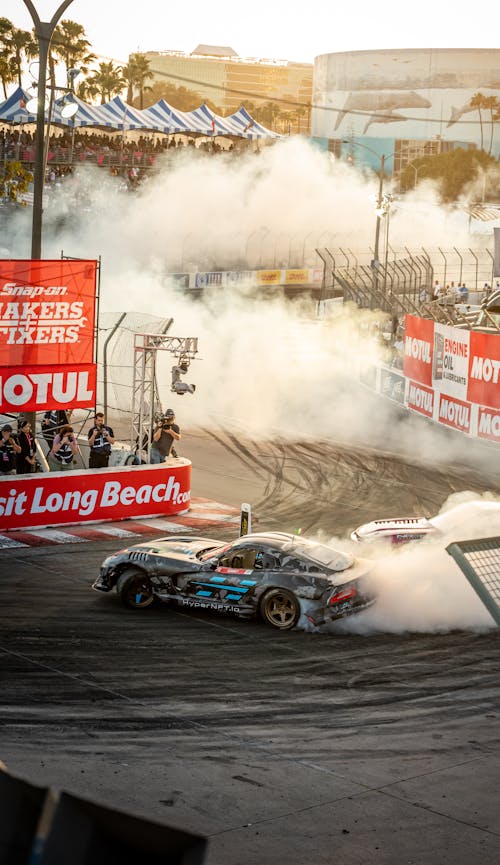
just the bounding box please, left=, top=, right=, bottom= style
left=0, top=259, right=97, bottom=412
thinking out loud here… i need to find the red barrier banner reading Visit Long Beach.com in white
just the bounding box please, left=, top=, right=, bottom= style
left=0, top=460, right=191, bottom=531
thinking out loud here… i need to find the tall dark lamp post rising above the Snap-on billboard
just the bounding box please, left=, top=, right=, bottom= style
left=24, top=0, right=73, bottom=259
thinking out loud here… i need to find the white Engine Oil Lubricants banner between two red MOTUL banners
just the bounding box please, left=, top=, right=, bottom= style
left=432, top=324, right=470, bottom=400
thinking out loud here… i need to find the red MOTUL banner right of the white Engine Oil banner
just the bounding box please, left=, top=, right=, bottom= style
left=467, top=332, right=500, bottom=409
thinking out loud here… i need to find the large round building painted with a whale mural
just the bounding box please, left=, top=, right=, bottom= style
left=311, top=48, right=500, bottom=171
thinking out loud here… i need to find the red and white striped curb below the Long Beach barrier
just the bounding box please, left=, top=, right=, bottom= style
left=0, top=498, right=240, bottom=550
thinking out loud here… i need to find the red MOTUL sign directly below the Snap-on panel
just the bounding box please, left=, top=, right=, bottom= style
left=0, top=363, right=96, bottom=413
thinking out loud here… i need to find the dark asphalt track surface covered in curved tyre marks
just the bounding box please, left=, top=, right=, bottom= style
left=0, top=431, right=500, bottom=865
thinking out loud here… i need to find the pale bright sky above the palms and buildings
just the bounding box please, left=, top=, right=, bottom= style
left=1, top=0, right=498, bottom=63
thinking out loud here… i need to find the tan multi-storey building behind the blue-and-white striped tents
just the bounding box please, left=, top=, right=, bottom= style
left=146, top=45, right=314, bottom=134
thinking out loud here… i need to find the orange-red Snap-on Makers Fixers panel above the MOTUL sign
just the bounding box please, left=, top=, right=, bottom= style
left=0, top=259, right=97, bottom=367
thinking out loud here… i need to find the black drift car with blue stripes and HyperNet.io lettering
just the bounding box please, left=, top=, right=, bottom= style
left=92, top=532, right=375, bottom=630
